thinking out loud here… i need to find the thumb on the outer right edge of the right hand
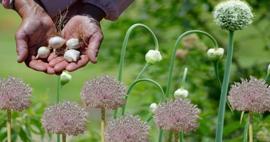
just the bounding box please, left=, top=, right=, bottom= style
left=87, top=33, right=103, bottom=63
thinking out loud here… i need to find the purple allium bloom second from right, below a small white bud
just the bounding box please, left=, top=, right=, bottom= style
left=154, top=98, right=200, bottom=133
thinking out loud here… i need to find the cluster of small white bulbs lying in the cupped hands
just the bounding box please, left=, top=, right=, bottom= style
left=36, top=36, right=80, bottom=62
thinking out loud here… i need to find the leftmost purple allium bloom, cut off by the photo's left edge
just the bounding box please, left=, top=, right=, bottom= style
left=0, top=77, right=32, bottom=111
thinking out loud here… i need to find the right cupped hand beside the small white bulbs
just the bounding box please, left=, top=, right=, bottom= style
left=50, top=15, right=103, bottom=72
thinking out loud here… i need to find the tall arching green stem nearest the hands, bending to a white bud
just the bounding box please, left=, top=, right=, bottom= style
left=114, top=23, right=159, bottom=118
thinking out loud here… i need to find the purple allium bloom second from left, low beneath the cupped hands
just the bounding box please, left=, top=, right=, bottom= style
left=42, top=102, right=87, bottom=136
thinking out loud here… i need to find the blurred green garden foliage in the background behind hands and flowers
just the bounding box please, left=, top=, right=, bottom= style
left=0, top=0, right=270, bottom=142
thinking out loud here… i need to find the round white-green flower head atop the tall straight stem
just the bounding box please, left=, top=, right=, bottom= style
left=214, top=0, right=254, bottom=31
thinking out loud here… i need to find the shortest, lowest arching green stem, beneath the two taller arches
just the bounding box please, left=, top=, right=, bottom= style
left=122, top=79, right=165, bottom=116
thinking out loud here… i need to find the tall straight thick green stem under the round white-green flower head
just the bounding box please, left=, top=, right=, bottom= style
left=215, top=31, right=234, bottom=142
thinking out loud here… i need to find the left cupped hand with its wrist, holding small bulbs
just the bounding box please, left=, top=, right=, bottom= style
left=15, top=0, right=56, bottom=73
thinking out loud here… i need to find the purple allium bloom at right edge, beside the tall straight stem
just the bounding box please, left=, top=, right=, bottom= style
left=228, top=77, right=270, bottom=113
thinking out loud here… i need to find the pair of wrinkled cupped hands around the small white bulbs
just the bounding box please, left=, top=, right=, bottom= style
left=11, top=0, right=103, bottom=74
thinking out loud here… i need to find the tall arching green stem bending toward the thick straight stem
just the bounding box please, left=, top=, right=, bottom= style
left=165, top=30, right=218, bottom=97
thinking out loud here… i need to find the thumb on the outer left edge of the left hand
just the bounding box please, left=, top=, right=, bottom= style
left=16, top=31, right=28, bottom=63
